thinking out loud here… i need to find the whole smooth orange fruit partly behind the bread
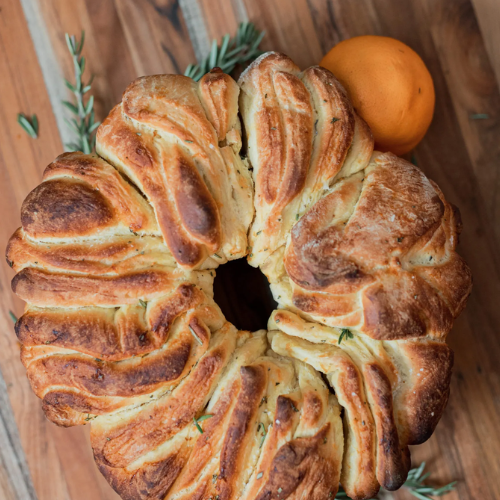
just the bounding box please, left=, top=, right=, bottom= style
left=320, top=36, right=435, bottom=155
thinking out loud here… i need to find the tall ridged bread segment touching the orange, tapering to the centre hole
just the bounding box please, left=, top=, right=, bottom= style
left=239, top=52, right=373, bottom=266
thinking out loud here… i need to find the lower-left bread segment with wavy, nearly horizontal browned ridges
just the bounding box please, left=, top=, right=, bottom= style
left=16, top=274, right=224, bottom=426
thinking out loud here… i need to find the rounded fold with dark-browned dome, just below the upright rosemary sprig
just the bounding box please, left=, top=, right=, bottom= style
left=21, top=153, right=157, bottom=241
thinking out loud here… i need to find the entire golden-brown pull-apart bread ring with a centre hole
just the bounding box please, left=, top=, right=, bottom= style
left=7, top=53, right=471, bottom=500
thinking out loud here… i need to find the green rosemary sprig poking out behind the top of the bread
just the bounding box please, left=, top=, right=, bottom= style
left=184, top=23, right=265, bottom=81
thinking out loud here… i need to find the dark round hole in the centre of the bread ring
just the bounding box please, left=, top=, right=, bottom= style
left=214, top=259, right=278, bottom=331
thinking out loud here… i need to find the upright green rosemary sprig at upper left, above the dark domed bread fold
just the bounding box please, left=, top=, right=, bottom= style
left=63, top=31, right=100, bottom=154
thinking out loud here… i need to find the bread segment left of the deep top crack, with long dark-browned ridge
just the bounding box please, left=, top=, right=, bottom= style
left=96, top=70, right=253, bottom=269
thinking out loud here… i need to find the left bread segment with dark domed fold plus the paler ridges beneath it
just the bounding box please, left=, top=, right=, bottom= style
left=6, top=153, right=176, bottom=280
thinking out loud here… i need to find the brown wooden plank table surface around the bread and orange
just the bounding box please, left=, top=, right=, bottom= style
left=0, top=0, right=500, bottom=500
